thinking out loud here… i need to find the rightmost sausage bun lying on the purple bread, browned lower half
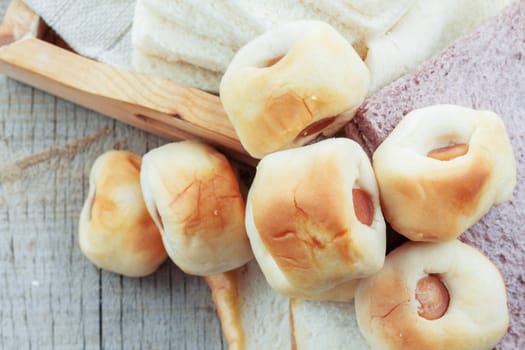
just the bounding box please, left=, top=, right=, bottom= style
left=373, top=105, right=516, bottom=241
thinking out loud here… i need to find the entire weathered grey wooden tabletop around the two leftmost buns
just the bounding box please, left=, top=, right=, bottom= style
left=0, top=0, right=227, bottom=349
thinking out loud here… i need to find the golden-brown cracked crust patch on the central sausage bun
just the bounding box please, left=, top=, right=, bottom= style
left=252, top=157, right=355, bottom=288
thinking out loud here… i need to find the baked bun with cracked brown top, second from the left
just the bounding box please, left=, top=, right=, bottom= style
left=141, top=141, right=253, bottom=276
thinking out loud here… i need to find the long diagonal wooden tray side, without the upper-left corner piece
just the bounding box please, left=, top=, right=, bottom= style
left=0, top=38, right=256, bottom=164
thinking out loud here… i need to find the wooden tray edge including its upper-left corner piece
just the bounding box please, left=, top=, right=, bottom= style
left=0, top=0, right=257, bottom=166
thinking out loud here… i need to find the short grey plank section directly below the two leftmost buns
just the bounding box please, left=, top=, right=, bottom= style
left=102, top=262, right=223, bottom=350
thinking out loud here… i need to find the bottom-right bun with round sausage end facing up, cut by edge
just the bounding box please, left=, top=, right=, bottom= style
left=355, top=240, right=509, bottom=350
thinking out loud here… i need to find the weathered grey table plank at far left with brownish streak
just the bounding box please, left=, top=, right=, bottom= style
left=0, top=77, right=104, bottom=349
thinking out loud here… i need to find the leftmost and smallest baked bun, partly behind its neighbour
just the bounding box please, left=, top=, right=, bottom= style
left=78, top=151, right=167, bottom=277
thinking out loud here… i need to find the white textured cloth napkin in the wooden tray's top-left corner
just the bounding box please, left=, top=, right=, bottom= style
left=25, top=0, right=135, bottom=68
